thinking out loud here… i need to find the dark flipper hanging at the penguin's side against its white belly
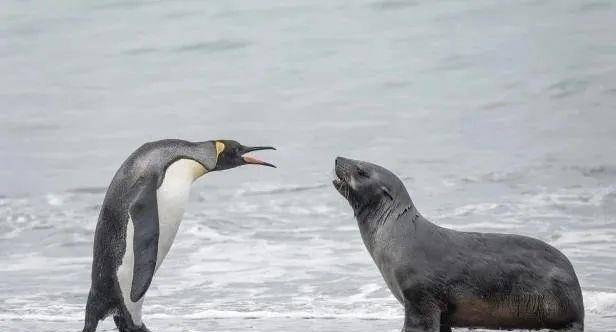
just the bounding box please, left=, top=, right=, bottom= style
left=128, top=179, right=159, bottom=302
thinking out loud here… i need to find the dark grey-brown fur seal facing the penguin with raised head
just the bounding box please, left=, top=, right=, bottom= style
left=334, top=157, right=584, bottom=331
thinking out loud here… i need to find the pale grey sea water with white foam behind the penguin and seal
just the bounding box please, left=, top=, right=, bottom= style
left=0, top=0, right=616, bottom=332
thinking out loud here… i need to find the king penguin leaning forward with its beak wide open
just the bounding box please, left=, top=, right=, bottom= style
left=83, top=139, right=275, bottom=332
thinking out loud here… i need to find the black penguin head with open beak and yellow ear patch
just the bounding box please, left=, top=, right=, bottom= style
left=213, top=140, right=276, bottom=171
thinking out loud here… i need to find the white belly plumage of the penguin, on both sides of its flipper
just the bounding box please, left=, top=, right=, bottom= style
left=117, top=159, right=206, bottom=326
